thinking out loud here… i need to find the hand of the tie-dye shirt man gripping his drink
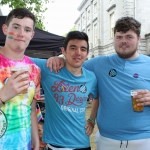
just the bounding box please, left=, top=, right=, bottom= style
left=0, top=70, right=29, bottom=102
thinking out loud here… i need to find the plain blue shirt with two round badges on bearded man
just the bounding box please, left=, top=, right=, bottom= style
left=84, top=54, right=150, bottom=140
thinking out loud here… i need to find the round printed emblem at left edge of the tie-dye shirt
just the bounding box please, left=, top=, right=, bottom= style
left=0, top=109, right=8, bottom=138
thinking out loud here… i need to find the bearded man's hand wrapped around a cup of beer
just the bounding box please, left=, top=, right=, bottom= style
left=134, top=90, right=150, bottom=106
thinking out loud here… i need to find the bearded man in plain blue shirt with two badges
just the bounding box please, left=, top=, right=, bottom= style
left=47, top=17, right=150, bottom=150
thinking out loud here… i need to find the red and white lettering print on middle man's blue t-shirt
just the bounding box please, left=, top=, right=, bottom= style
left=51, top=81, right=88, bottom=113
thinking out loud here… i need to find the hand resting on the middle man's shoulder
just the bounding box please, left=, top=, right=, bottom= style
left=46, top=57, right=65, bottom=73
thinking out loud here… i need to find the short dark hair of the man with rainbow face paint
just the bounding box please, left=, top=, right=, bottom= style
left=5, top=8, right=36, bottom=29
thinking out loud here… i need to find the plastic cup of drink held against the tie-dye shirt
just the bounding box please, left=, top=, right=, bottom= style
left=11, top=66, right=29, bottom=94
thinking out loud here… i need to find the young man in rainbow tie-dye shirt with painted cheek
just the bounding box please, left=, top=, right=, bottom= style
left=0, top=8, right=40, bottom=150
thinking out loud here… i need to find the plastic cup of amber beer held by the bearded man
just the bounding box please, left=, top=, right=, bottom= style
left=131, top=90, right=144, bottom=112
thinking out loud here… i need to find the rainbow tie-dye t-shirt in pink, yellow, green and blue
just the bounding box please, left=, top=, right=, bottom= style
left=0, top=54, right=40, bottom=150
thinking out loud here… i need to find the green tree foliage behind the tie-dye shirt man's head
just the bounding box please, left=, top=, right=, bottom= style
left=0, top=0, right=53, bottom=30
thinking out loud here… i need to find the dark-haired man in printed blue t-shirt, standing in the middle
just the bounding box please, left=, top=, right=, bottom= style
left=31, top=31, right=98, bottom=150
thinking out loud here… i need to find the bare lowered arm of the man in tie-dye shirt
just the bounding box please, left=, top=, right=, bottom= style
left=31, top=100, right=40, bottom=150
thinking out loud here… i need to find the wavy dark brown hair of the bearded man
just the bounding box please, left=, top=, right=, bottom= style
left=114, top=17, right=141, bottom=36
